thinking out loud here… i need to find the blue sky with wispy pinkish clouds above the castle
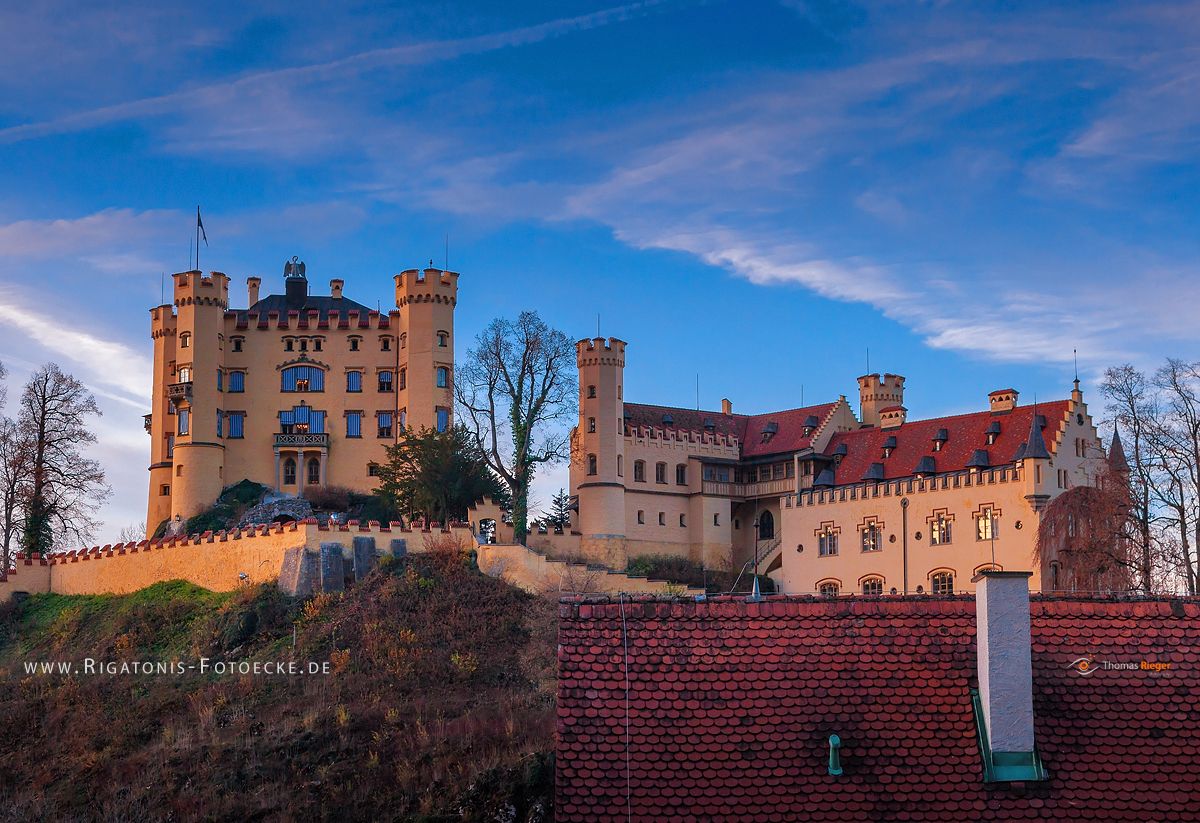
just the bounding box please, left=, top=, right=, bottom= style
left=0, top=0, right=1200, bottom=542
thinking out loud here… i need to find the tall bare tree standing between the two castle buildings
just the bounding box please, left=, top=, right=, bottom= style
left=455, top=312, right=576, bottom=543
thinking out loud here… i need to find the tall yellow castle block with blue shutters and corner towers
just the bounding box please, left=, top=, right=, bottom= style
left=145, top=258, right=458, bottom=531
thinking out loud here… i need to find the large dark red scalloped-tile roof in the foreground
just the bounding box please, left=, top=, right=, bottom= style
left=556, top=597, right=1200, bottom=823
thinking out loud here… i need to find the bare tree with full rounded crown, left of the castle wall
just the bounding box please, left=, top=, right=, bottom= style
left=17, top=364, right=109, bottom=554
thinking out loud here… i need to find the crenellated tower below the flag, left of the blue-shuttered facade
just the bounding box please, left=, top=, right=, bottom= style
left=168, top=271, right=229, bottom=530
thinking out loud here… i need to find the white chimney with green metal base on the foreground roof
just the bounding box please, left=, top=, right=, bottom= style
left=971, top=570, right=1045, bottom=781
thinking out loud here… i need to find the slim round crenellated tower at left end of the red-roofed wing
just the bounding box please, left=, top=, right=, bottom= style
left=572, top=337, right=625, bottom=569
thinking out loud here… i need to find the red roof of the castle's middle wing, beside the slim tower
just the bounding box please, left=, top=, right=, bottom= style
left=625, top=403, right=836, bottom=458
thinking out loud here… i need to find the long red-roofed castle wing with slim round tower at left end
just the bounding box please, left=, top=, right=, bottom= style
left=570, top=338, right=1123, bottom=595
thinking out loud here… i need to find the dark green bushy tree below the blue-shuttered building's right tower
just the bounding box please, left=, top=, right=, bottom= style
left=374, top=426, right=509, bottom=522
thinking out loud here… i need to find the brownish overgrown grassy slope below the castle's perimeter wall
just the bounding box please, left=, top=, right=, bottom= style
left=0, top=555, right=556, bottom=821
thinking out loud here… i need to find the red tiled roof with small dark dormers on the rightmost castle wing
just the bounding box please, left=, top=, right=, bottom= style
left=824, top=400, right=1070, bottom=486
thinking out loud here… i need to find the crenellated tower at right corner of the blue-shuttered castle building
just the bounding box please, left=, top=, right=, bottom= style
left=395, top=268, right=458, bottom=439
